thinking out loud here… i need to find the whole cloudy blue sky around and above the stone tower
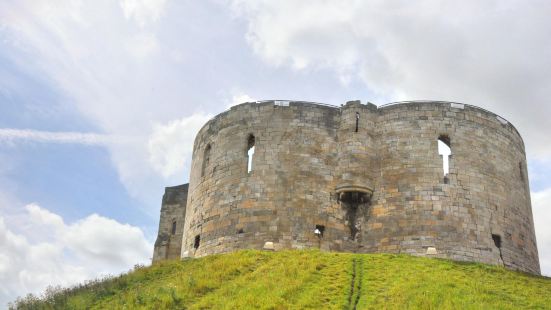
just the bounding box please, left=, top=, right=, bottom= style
left=0, top=0, right=551, bottom=304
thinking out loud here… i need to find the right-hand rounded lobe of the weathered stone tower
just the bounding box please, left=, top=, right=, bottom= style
left=364, top=103, right=539, bottom=273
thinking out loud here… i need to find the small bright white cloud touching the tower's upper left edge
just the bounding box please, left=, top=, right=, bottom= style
left=148, top=114, right=212, bottom=178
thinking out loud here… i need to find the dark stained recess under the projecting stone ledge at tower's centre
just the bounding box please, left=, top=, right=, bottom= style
left=339, top=191, right=370, bottom=240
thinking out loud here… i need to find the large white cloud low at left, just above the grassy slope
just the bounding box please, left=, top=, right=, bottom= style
left=0, top=204, right=153, bottom=305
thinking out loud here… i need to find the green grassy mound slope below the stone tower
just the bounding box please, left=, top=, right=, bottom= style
left=12, top=250, right=551, bottom=309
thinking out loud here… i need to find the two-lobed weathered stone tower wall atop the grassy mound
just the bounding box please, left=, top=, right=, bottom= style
left=155, top=101, right=540, bottom=274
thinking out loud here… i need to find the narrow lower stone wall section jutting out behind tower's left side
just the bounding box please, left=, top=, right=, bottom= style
left=153, top=184, right=189, bottom=262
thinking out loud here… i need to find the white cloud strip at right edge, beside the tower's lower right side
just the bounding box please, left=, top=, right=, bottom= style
left=532, top=188, right=551, bottom=276
